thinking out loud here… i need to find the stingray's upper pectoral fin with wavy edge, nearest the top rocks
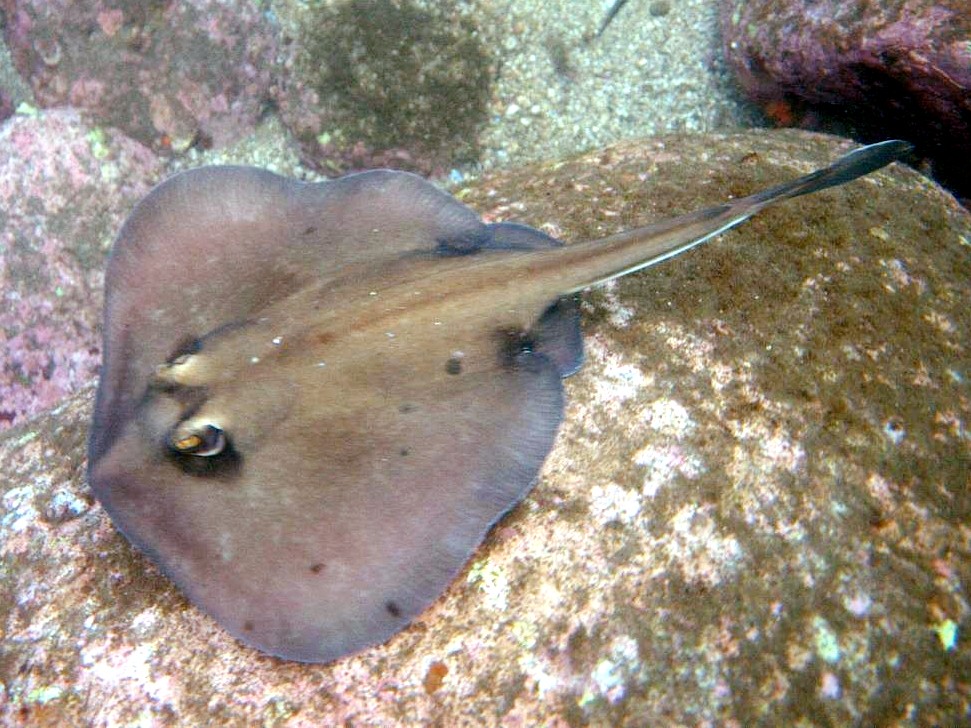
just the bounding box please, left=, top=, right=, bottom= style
left=90, top=166, right=494, bottom=458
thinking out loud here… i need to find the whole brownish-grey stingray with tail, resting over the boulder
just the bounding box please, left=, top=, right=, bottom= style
left=88, top=141, right=910, bottom=662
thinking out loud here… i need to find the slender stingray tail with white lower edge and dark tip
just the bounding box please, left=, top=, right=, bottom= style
left=558, top=140, right=913, bottom=293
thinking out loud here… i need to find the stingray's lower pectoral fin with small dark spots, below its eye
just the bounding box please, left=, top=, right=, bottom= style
left=91, top=353, right=563, bottom=662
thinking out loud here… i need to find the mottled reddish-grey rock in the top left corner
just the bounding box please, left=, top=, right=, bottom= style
left=0, top=0, right=277, bottom=151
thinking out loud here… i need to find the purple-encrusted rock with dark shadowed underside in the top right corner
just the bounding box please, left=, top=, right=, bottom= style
left=721, top=0, right=971, bottom=203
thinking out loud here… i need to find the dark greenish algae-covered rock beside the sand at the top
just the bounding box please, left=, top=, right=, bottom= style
left=279, top=0, right=495, bottom=174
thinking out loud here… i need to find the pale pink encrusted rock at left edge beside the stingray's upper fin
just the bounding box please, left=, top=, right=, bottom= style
left=0, top=110, right=160, bottom=429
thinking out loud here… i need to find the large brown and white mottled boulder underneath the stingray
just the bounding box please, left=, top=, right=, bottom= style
left=0, top=132, right=971, bottom=725
